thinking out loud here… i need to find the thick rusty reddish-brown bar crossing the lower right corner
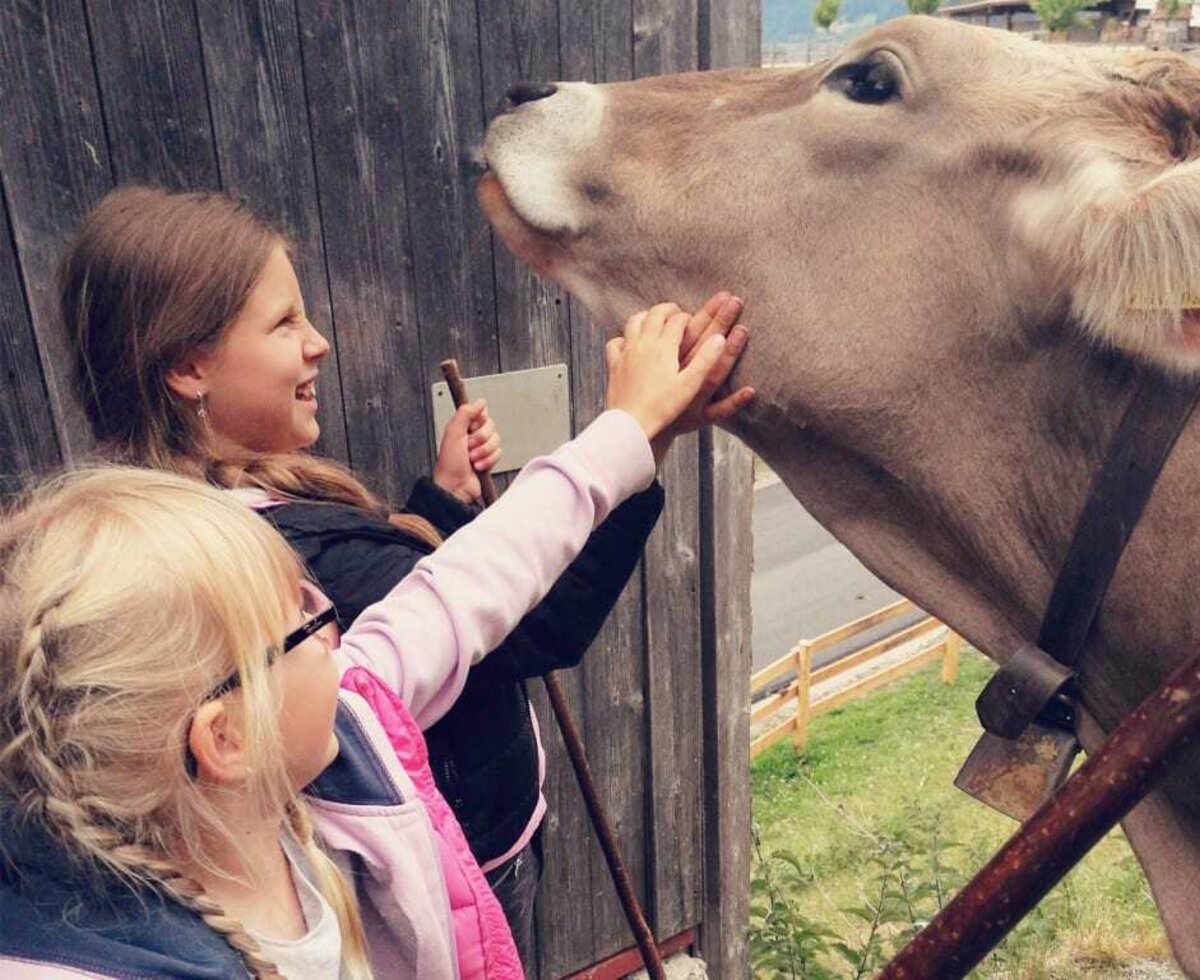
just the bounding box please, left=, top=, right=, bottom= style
left=880, top=655, right=1200, bottom=980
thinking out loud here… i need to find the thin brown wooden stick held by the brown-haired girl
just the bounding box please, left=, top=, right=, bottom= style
left=442, top=357, right=666, bottom=980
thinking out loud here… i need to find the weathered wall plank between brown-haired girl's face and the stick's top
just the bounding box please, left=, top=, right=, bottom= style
left=299, top=0, right=433, bottom=504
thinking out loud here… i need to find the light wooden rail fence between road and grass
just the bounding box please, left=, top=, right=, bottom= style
left=750, top=599, right=962, bottom=758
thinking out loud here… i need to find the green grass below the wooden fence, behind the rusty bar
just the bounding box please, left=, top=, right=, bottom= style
left=751, top=651, right=1171, bottom=980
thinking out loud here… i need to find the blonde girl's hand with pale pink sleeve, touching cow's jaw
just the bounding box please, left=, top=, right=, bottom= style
left=605, top=303, right=725, bottom=441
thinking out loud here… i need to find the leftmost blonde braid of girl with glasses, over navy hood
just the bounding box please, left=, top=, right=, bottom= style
left=4, top=609, right=283, bottom=980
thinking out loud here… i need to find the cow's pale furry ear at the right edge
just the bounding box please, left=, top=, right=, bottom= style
left=1062, top=154, right=1200, bottom=374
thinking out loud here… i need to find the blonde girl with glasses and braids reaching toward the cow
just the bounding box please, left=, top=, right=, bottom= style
left=0, top=309, right=721, bottom=980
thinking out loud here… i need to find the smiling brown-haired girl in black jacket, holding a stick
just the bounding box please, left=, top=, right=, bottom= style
left=60, top=187, right=749, bottom=963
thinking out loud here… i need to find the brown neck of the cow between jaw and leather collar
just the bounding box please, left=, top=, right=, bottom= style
left=724, top=327, right=1176, bottom=695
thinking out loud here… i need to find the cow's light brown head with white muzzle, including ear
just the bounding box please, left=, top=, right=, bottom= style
left=481, top=18, right=1200, bottom=378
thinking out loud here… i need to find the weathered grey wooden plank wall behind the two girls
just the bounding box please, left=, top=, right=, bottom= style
left=0, top=0, right=760, bottom=978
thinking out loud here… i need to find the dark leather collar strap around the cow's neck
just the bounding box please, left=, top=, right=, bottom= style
left=976, top=367, right=1200, bottom=739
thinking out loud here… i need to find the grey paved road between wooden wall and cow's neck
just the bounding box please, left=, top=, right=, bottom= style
left=750, top=483, right=912, bottom=671
